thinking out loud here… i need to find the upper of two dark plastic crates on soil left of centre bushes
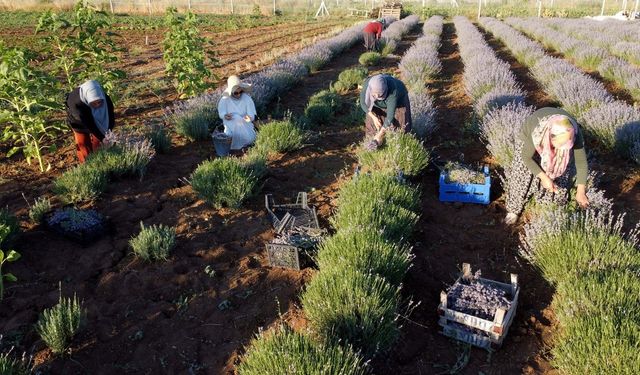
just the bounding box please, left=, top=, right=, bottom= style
left=264, top=192, right=320, bottom=233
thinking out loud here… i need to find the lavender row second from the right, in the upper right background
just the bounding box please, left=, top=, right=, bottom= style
left=506, top=18, right=640, bottom=100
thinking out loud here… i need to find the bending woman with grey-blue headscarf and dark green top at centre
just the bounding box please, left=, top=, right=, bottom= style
left=360, top=74, right=411, bottom=147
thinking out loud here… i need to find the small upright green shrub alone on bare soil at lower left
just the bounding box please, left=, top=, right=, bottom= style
left=36, top=295, right=86, bottom=354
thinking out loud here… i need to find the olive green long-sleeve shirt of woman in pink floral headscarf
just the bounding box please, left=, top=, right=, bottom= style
left=520, top=107, right=589, bottom=185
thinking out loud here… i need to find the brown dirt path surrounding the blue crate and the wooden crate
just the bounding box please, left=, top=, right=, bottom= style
left=376, top=23, right=553, bottom=374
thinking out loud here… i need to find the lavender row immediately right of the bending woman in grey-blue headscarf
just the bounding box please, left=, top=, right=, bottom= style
left=399, top=16, right=443, bottom=139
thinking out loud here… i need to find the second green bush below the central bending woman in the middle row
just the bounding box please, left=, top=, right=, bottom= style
left=337, top=172, right=421, bottom=213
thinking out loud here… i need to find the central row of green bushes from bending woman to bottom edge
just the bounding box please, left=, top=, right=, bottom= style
left=239, top=20, right=428, bottom=374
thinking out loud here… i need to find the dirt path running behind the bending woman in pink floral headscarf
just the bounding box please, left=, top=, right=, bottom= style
left=476, top=25, right=640, bottom=229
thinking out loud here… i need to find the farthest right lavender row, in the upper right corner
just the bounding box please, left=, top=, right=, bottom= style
left=547, top=19, right=640, bottom=65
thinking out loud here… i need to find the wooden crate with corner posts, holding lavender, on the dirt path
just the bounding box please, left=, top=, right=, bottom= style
left=438, top=263, right=520, bottom=350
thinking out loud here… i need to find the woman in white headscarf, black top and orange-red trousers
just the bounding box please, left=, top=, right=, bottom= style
left=65, top=80, right=115, bottom=163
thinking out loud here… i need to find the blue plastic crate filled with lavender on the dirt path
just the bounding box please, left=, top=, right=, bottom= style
left=439, top=162, right=491, bottom=204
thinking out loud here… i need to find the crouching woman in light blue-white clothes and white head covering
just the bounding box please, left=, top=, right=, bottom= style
left=218, top=75, right=256, bottom=151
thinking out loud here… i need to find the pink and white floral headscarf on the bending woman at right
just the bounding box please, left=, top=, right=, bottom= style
left=531, top=115, right=578, bottom=180
